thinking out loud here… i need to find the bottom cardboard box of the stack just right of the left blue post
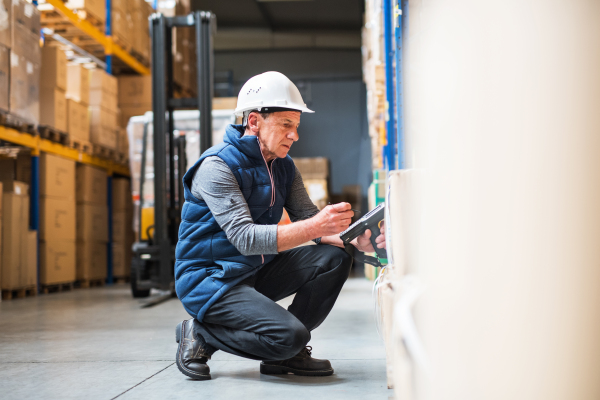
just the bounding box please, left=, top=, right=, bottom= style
left=40, top=239, right=75, bottom=285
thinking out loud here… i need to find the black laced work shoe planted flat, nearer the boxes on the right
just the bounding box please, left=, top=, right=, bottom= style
left=260, top=346, right=333, bottom=376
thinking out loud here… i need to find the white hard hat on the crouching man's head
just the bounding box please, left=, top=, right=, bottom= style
left=235, top=71, right=314, bottom=116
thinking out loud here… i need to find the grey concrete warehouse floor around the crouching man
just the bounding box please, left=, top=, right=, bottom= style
left=0, top=278, right=393, bottom=400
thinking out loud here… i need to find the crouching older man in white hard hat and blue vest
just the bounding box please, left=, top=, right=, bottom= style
left=175, top=72, right=385, bottom=380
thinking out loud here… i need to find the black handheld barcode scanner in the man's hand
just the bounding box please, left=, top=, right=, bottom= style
left=340, top=203, right=387, bottom=267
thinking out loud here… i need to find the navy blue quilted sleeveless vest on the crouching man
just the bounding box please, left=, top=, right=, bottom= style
left=175, top=125, right=295, bottom=321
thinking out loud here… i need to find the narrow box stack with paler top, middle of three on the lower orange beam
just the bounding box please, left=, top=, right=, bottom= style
left=66, top=63, right=90, bottom=142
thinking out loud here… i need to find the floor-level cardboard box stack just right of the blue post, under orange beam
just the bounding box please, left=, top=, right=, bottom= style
left=40, top=153, right=76, bottom=285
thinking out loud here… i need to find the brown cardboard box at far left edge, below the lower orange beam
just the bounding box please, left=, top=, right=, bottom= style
left=0, top=181, right=29, bottom=290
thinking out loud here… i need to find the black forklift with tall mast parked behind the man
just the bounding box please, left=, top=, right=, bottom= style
left=131, top=11, right=216, bottom=298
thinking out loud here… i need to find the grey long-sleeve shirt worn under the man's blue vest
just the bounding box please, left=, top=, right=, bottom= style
left=191, top=156, right=319, bottom=256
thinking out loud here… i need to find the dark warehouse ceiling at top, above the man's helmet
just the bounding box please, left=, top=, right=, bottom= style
left=191, top=0, right=364, bottom=51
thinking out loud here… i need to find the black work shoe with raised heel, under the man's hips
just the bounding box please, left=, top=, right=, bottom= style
left=175, top=318, right=211, bottom=380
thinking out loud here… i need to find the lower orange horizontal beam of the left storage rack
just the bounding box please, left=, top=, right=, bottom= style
left=0, top=126, right=130, bottom=176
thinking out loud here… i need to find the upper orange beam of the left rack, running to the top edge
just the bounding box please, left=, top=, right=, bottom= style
left=40, top=0, right=150, bottom=75
